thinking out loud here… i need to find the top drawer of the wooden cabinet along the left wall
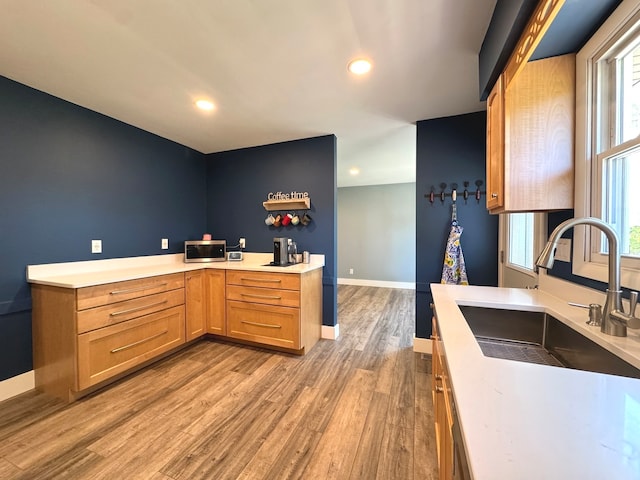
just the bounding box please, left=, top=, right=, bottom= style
left=76, top=273, right=184, bottom=310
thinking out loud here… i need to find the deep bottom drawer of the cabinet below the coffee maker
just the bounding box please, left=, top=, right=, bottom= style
left=227, top=300, right=302, bottom=350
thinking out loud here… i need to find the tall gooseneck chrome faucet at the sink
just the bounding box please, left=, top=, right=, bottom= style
left=536, top=217, right=640, bottom=337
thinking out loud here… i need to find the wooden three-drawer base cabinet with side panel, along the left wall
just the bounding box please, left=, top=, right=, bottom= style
left=32, top=273, right=185, bottom=401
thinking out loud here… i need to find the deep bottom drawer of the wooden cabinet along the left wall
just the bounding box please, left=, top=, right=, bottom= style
left=78, top=306, right=185, bottom=390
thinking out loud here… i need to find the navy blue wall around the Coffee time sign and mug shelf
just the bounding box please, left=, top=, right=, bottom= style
left=207, top=135, right=337, bottom=326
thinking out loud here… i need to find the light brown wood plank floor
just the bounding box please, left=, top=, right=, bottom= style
left=0, top=286, right=437, bottom=480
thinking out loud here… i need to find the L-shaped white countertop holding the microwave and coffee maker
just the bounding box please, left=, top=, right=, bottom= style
left=27, top=252, right=324, bottom=288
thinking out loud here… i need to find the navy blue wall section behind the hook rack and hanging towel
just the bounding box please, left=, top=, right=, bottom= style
left=416, top=112, right=498, bottom=338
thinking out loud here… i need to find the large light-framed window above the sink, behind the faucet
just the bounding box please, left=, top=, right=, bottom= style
left=574, top=0, right=640, bottom=288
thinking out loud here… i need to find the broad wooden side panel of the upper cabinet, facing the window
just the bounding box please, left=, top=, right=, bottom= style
left=502, top=54, right=576, bottom=212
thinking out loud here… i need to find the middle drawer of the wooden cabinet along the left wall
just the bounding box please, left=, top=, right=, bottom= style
left=77, top=288, right=184, bottom=333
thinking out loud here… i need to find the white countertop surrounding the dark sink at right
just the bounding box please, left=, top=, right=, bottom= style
left=431, top=284, right=640, bottom=480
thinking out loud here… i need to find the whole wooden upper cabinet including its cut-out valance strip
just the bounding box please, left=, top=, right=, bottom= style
left=487, top=0, right=576, bottom=213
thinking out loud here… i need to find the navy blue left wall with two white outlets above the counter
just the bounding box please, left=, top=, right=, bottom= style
left=0, top=77, right=206, bottom=380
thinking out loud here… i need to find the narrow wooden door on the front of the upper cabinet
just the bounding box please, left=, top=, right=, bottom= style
left=487, top=75, right=505, bottom=210
